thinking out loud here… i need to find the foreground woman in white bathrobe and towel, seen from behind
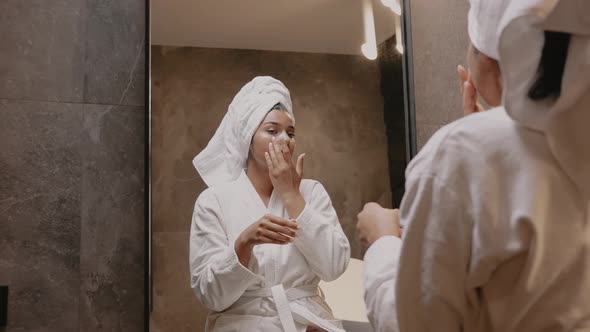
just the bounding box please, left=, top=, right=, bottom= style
left=358, top=0, right=590, bottom=332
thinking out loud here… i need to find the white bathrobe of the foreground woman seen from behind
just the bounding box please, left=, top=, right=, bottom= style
left=365, top=107, right=590, bottom=332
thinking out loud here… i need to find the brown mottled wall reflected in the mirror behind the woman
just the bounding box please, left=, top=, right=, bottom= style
left=150, top=46, right=404, bottom=331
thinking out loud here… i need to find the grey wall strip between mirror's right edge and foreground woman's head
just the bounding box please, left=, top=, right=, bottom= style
left=410, top=0, right=469, bottom=148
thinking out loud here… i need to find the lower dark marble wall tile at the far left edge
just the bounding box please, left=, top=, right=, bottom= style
left=0, top=99, right=82, bottom=331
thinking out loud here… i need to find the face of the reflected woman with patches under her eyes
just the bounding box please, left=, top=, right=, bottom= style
left=249, top=110, right=295, bottom=168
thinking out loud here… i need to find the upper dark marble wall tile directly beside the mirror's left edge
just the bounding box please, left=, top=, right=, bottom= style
left=84, top=0, right=146, bottom=106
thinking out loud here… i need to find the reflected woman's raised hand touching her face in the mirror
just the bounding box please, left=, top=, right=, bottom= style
left=264, top=137, right=305, bottom=202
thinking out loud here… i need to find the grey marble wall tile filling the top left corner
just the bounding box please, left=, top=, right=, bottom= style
left=0, top=0, right=86, bottom=102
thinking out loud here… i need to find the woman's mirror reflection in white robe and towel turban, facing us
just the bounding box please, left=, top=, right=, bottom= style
left=190, top=77, right=350, bottom=332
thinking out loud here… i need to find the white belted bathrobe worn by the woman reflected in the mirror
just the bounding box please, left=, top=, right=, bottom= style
left=190, top=172, right=350, bottom=332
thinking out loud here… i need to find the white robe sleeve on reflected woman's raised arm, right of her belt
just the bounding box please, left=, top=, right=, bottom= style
left=293, top=181, right=350, bottom=281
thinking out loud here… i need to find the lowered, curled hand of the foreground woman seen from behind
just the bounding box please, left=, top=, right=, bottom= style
left=356, top=203, right=401, bottom=252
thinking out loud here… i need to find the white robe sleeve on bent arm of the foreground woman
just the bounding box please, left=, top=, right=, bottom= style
left=365, top=174, right=471, bottom=332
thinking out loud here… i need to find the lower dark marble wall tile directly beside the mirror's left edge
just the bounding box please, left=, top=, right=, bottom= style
left=79, top=105, right=147, bottom=332
